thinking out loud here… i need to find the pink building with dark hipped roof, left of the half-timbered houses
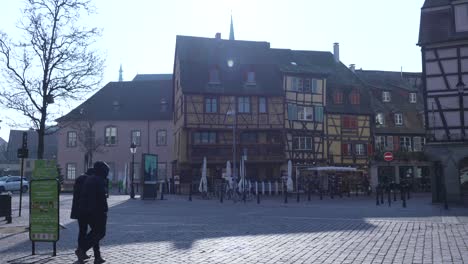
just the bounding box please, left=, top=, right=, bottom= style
left=57, top=75, right=173, bottom=190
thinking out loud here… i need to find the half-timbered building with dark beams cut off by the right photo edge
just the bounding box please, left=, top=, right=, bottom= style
left=418, top=0, right=468, bottom=201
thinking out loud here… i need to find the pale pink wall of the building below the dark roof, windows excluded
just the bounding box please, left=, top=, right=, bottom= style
left=58, top=120, right=174, bottom=185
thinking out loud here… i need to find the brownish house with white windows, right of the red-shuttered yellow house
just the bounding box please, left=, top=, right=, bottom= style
left=356, top=70, right=432, bottom=192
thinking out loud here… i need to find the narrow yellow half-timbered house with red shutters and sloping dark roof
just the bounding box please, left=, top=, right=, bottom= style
left=325, top=59, right=372, bottom=175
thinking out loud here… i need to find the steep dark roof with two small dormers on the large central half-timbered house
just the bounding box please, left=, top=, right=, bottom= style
left=176, top=36, right=282, bottom=95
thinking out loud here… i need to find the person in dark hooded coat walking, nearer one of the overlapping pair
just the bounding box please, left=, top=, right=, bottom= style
left=75, top=161, right=109, bottom=264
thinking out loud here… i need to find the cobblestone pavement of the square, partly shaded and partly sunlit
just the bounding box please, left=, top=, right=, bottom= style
left=0, top=192, right=468, bottom=263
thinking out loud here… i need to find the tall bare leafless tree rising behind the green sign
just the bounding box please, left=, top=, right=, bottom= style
left=0, top=0, right=104, bottom=159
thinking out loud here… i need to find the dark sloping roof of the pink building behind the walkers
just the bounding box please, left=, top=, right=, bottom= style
left=57, top=80, right=173, bottom=122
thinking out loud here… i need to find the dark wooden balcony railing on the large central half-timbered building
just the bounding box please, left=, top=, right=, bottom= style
left=190, top=144, right=285, bottom=162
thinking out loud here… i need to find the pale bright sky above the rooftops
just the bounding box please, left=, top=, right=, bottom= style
left=0, top=0, right=424, bottom=140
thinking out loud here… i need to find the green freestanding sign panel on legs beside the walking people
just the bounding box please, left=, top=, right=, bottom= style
left=29, top=160, right=60, bottom=256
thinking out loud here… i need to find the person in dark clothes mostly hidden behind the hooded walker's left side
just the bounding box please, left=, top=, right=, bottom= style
left=70, top=168, right=99, bottom=259
